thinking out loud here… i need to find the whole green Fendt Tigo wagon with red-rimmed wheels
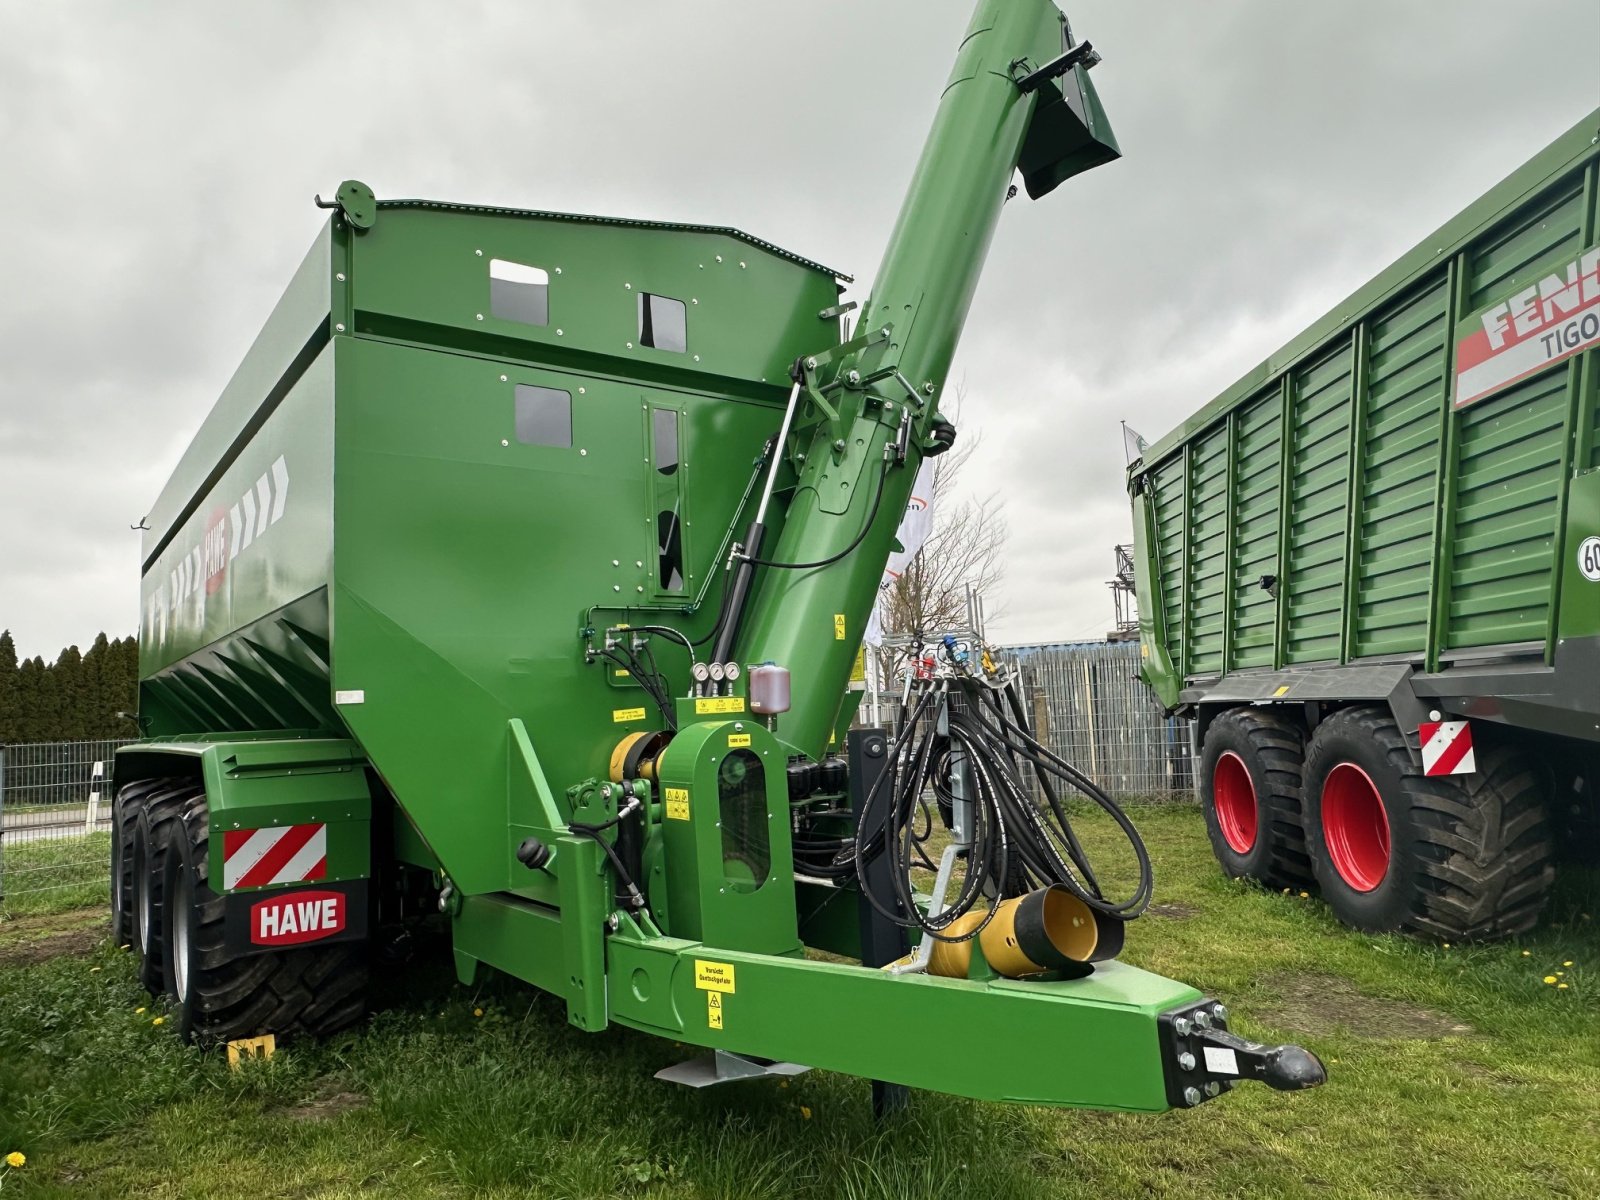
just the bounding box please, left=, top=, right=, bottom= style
left=1128, top=112, right=1600, bottom=939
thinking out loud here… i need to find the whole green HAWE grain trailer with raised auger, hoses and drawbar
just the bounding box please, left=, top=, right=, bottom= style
left=112, top=0, right=1323, bottom=1112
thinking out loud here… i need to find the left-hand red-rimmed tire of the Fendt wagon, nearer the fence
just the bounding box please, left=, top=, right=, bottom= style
left=1200, top=707, right=1312, bottom=888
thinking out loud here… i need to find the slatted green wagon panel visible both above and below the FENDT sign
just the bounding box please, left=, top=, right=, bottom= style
left=1445, top=176, right=1582, bottom=648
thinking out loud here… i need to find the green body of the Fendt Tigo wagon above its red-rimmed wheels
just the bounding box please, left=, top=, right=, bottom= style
left=1128, top=112, right=1600, bottom=931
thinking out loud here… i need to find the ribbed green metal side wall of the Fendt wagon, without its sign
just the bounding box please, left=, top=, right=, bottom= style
left=1130, top=112, right=1600, bottom=710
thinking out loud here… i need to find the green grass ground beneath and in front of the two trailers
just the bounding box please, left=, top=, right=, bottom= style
left=0, top=808, right=1600, bottom=1200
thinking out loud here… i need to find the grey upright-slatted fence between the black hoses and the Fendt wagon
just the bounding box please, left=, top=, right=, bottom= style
left=1002, top=642, right=1195, bottom=800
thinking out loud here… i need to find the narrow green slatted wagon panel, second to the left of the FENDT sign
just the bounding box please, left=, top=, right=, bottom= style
left=1280, top=344, right=1350, bottom=662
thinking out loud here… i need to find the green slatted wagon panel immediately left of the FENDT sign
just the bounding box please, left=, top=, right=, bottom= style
left=1350, top=272, right=1450, bottom=658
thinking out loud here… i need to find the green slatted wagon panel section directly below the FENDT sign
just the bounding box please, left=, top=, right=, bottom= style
left=1445, top=368, right=1570, bottom=648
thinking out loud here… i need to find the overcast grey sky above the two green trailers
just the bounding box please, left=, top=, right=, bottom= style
left=0, top=0, right=1600, bottom=658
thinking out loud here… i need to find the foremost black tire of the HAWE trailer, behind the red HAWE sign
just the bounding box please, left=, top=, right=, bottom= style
left=162, top=797, right=366, bottom=1045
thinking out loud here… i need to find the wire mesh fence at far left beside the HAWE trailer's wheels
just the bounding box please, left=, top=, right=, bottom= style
left=0, top=741, right=123, bottom=910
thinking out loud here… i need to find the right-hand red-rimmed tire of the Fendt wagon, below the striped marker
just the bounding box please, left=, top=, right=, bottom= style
left=1306, top=707, right=1555, bottom=941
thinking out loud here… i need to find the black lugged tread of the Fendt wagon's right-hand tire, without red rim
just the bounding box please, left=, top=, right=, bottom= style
left=1325, top=707, right=1555, bottom=941
